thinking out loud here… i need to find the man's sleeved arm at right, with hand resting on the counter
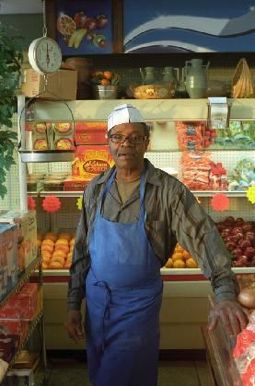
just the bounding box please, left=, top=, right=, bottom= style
left=172, top=185, right=248, bottom=335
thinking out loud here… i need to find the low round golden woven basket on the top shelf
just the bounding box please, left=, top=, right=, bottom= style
left=131, top=83, right=175, bottom=99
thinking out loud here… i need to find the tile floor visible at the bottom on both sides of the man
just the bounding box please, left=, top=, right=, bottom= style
left=45, top=360, right=211, bottom=386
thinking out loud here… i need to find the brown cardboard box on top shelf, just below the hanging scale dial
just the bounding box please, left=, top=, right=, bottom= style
left=21, top=68, right=77, bottom=100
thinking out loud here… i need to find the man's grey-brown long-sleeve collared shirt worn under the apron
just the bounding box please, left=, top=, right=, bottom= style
left=68, top=159, right=238, bottom=309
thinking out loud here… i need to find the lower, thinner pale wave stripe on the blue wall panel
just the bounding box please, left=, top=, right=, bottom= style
left=125, top=40, right=216, bottom=53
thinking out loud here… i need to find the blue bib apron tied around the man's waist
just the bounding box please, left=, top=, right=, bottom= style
left=85, top=172, right=163, bottom=386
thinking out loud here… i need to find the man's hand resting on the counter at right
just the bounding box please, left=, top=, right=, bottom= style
left=208, top=300, right=248, bottom=337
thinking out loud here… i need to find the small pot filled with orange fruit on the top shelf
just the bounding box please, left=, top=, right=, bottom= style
left=91, top=71, right=120, bottom=99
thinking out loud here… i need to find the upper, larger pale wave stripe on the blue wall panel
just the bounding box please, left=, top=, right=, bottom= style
left=124, top=9, right=255, bottom=45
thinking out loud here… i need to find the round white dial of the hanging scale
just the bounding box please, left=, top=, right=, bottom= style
left=28, top=36, right=62, bottom=74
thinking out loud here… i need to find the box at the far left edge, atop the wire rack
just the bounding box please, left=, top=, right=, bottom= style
left=0, top=224, right=18, bottom=300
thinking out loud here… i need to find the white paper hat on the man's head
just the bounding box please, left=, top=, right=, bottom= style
left=107, top=104, right=145, bottom=131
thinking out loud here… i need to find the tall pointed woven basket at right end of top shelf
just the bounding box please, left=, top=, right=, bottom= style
left=232, top=58, right=254, bottom=98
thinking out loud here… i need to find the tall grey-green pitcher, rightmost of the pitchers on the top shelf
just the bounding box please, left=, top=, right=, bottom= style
left=185, top=59, right=210, bottom=98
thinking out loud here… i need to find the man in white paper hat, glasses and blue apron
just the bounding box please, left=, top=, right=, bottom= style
left=67, top=104, right=247, bottom=386
